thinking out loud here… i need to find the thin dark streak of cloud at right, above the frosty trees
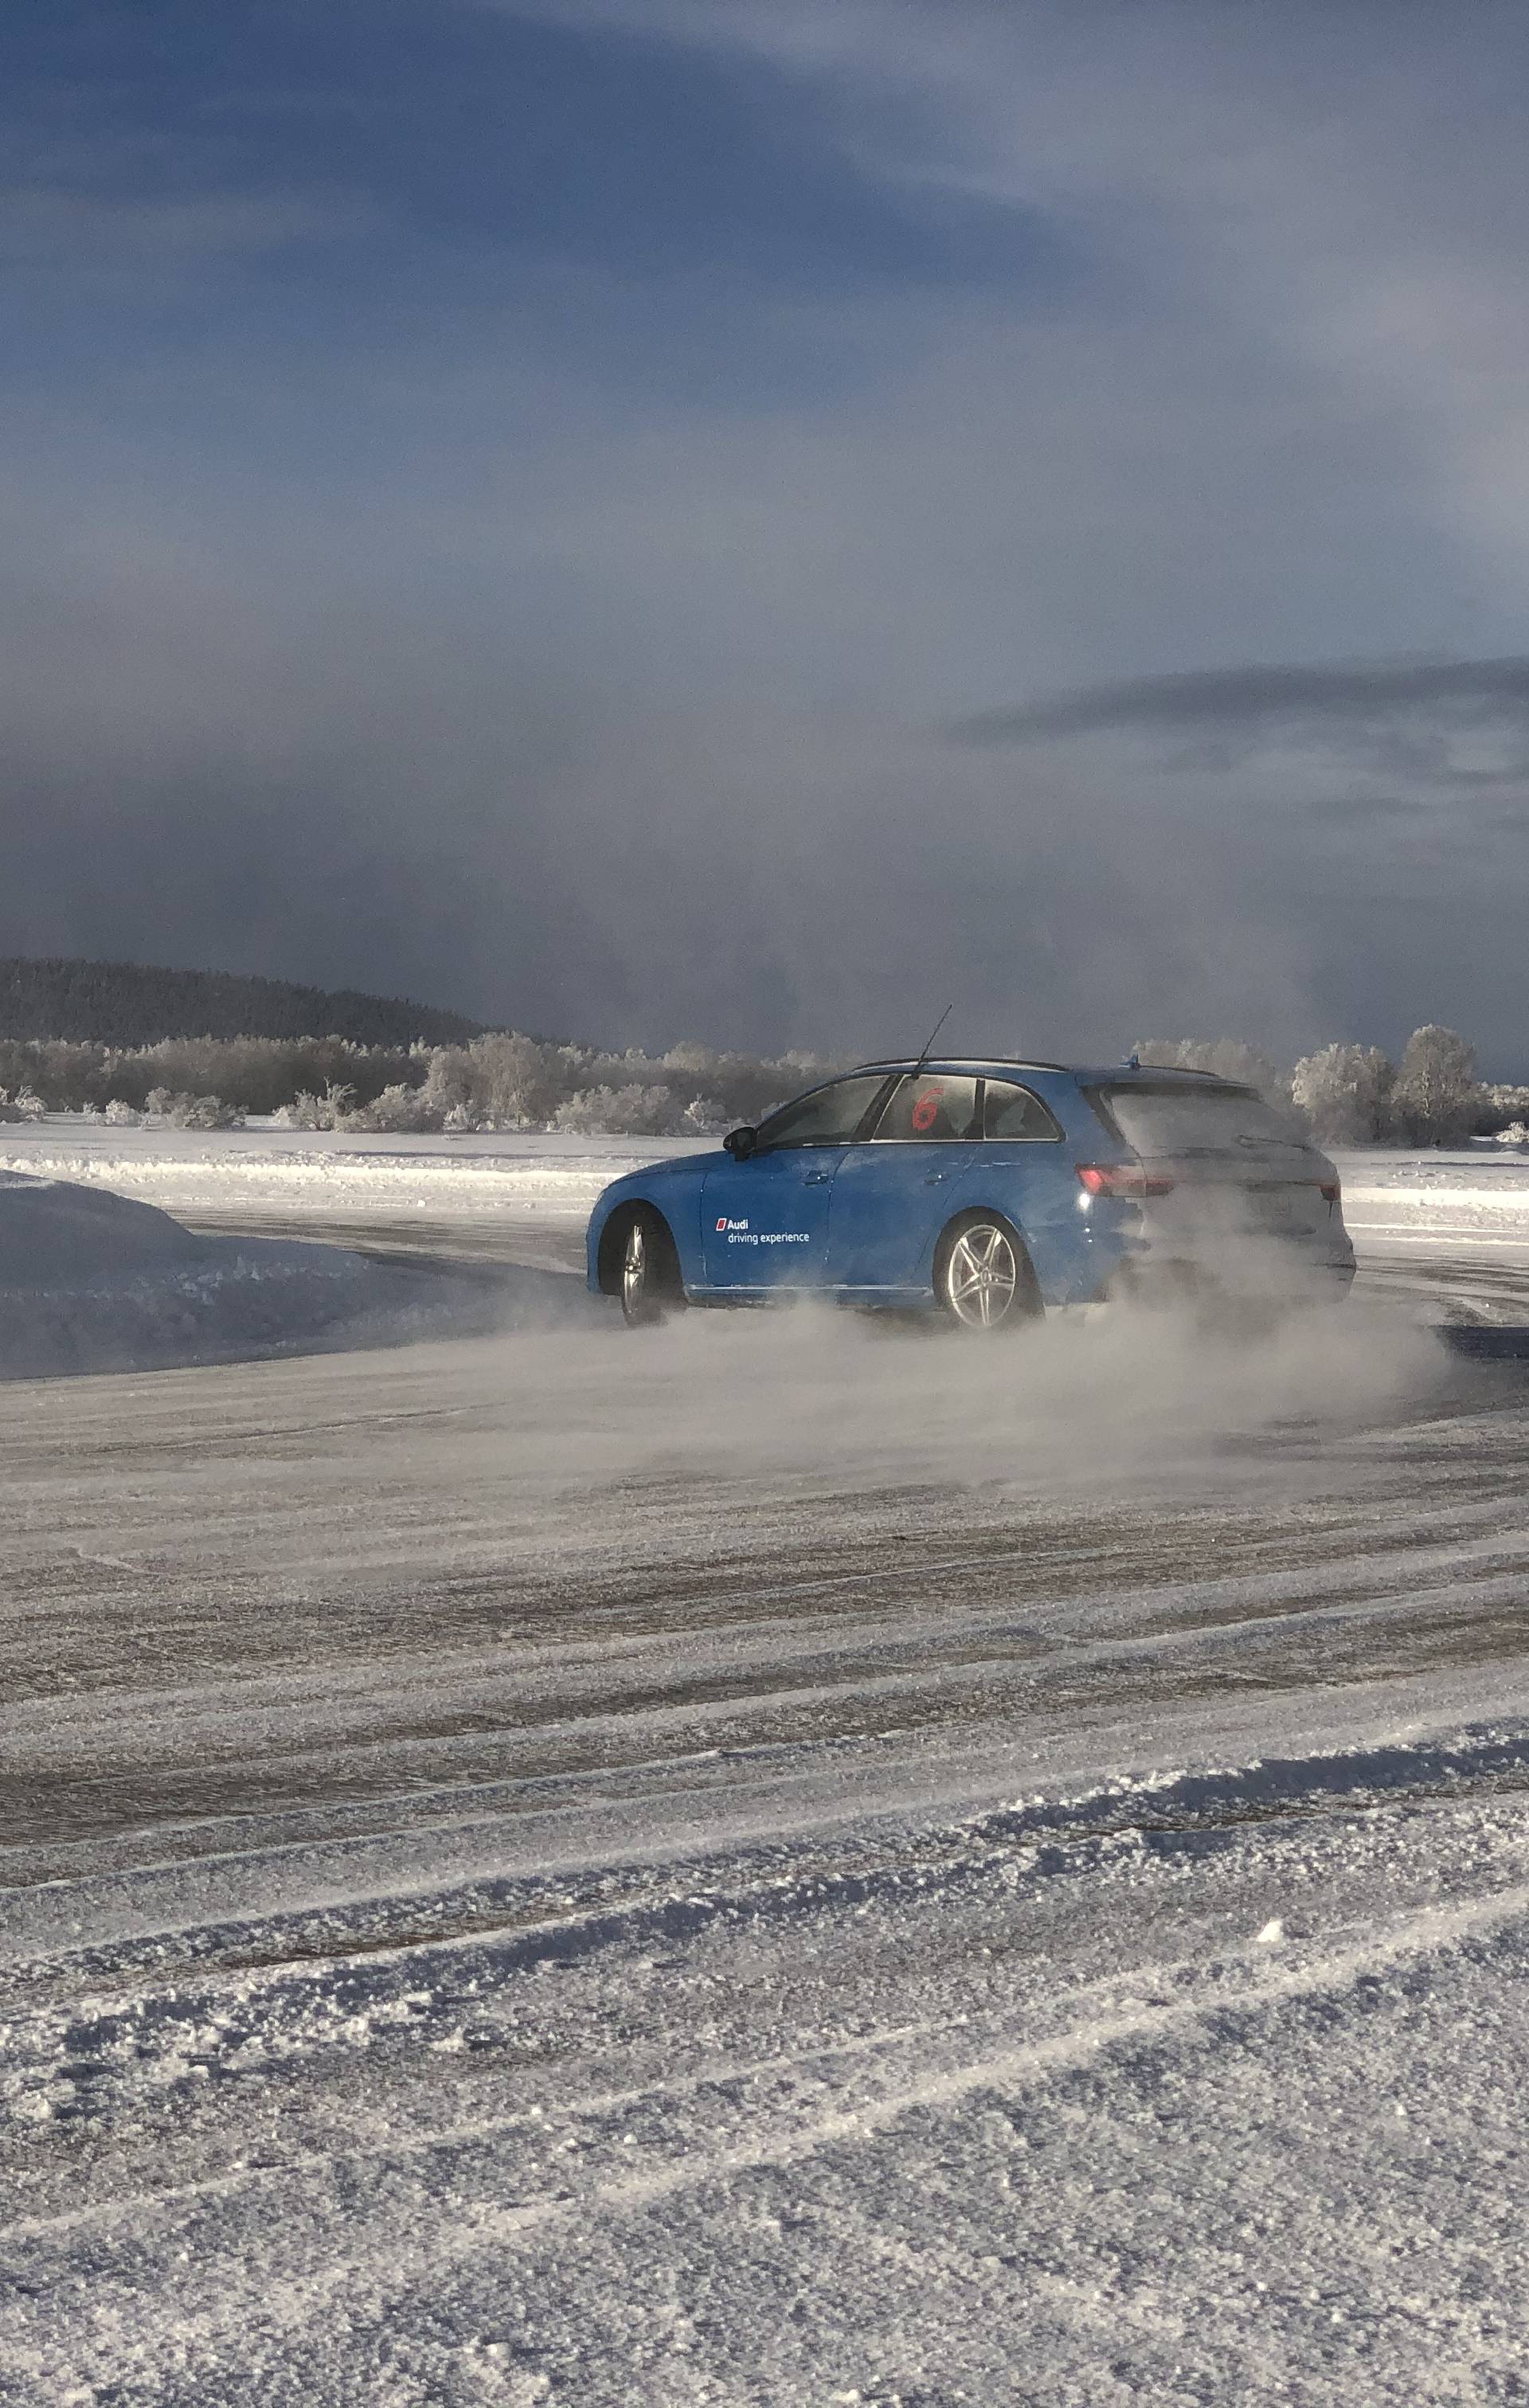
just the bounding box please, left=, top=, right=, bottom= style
left=948, top=653, right=1529, bottom=744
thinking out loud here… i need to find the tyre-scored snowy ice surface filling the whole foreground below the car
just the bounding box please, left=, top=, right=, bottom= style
left=0, top=1272, right=1529, bottom=2408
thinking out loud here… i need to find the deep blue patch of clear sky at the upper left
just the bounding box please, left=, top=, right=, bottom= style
left=0, top=0, right=1077, bottom=370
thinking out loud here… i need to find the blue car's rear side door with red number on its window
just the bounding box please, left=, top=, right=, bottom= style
left=828, top=1069, right=983, bottom=1296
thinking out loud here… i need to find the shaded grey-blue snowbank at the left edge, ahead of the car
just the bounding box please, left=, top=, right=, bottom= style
left=0, top=1171, right=507, bottom=1380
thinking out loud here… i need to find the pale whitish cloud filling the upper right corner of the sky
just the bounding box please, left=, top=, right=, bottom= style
left=491, top=0, right=1529, bottom=607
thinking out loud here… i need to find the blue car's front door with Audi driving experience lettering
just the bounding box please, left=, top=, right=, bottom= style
left=701, top=1072, right=889, bottom=1296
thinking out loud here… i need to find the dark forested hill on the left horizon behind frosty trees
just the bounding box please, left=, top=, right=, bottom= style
left=0, top=961, right=482, bottom=1045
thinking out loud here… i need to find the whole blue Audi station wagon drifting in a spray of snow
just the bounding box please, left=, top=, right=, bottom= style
left=588, top=1060, right=1353, bottom=1331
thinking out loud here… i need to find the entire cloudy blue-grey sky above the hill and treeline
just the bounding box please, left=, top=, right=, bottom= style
left=0, top=0, right=1529, bottom=1069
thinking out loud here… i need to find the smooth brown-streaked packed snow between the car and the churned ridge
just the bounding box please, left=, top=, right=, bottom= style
left=0, top=1274, right=1529, bottom=1874
